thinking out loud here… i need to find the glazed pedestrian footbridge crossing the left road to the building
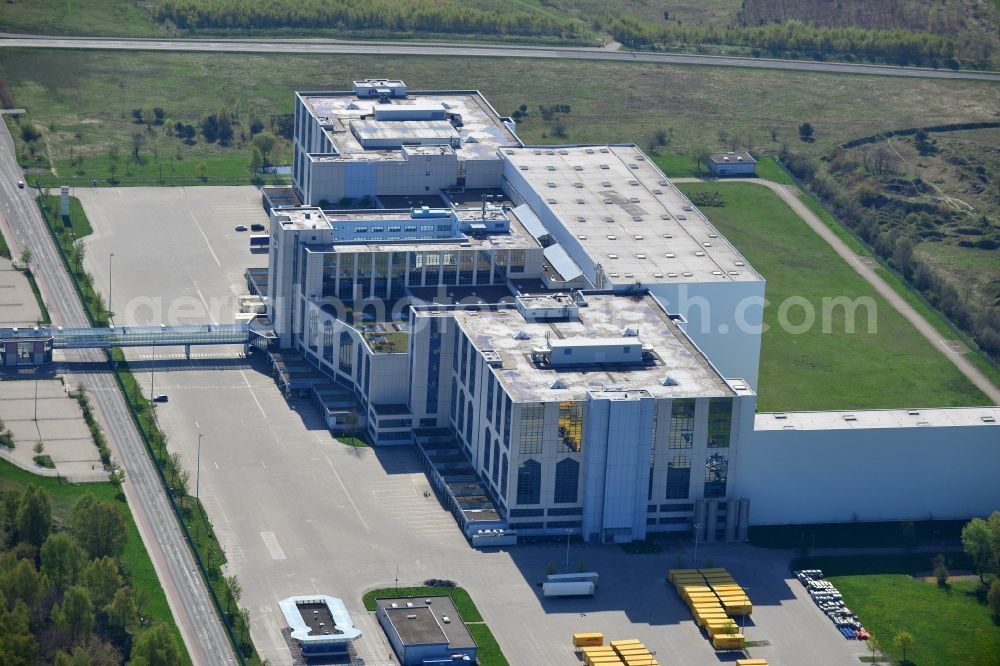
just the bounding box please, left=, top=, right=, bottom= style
left=0, top=318, right=275, bottom=367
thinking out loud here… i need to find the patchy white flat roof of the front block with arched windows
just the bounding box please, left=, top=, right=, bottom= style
left=415, top=294, right=740, bottom=402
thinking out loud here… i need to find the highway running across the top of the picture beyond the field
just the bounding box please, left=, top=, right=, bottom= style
left=0, top=34, right=1000, bottom=81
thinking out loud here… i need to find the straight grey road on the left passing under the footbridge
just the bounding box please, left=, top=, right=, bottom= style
left=0, top=122, right=235, bottom=666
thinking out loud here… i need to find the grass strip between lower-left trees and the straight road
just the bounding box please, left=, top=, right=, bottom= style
left=0, top=460, right=191, bottom=664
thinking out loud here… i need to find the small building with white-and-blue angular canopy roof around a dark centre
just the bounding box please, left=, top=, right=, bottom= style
left=278, top=595, right=361, bottom=658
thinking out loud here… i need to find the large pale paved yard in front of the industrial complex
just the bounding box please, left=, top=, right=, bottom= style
left=77, top=187, right=864, bottom=666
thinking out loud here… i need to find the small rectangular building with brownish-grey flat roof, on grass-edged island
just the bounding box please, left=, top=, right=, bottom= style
left=375, top=597, right=477, bottom=666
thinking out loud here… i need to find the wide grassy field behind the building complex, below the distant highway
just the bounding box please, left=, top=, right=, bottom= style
left=0, top=49, right=1000, bottom=186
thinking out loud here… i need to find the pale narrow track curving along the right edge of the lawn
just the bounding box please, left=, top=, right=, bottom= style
left=674, top=178, right=1000, bottom=405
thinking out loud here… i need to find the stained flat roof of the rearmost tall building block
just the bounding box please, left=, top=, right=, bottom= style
left=298, top=90, right=521, bottom=159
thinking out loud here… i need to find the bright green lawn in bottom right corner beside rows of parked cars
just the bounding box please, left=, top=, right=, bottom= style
left=829, top=574, right=1000, bottom=666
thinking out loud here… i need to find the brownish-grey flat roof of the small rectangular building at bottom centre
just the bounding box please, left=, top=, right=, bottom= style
left=375, top=597, right=476, bottom=650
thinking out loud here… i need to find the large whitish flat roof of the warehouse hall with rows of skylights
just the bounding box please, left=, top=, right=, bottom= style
left=501, top=146, right=763, bottom=285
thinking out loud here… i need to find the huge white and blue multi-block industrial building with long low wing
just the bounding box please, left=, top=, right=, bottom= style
left=264, top=80, right=1000, bottom=543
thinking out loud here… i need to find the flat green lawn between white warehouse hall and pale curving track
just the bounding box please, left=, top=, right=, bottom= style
left=681, top=182, right=988, bottom=411
